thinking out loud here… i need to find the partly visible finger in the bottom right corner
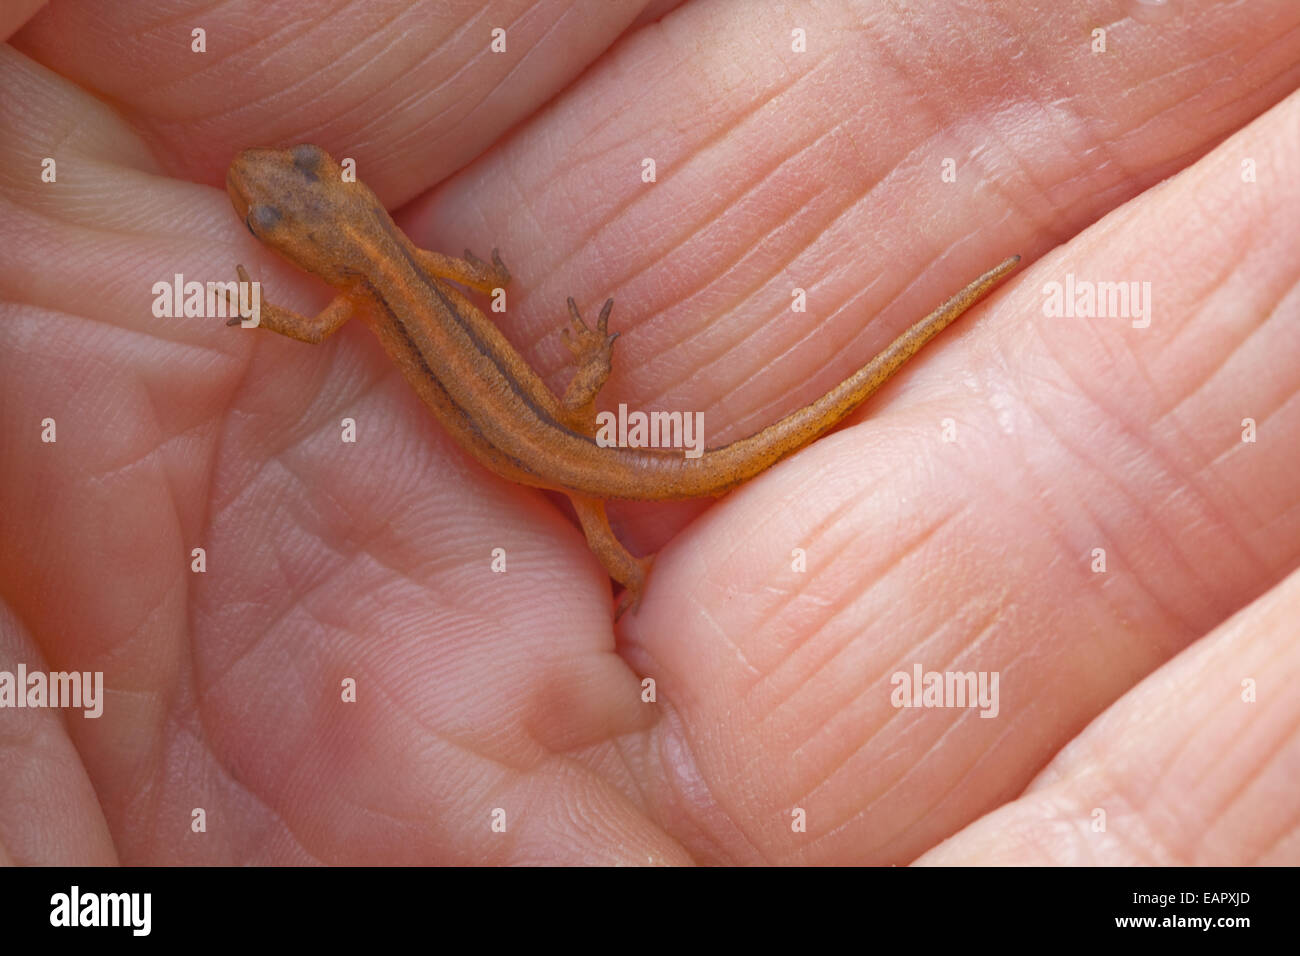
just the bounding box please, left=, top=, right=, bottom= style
left=919, top=572, right=1300, bottom=866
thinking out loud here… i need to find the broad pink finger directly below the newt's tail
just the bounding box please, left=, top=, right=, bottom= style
left=629, top=87, right=1300, bottom=862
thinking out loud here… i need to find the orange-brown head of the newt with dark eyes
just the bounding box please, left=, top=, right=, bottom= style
left=226, top=143, right=387, bottom=285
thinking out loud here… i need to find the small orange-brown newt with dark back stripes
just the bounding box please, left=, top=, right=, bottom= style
left=226, top=144, right=1019, bottom=614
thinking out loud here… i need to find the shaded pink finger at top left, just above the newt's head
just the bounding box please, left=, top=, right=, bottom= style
left=5, top=0, right=644, bottom=206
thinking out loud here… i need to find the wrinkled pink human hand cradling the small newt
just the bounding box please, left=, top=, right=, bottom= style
left=0, top=3, right=1300, bottom=864
